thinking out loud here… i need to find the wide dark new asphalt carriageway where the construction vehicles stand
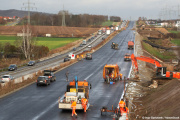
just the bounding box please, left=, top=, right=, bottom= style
left=0, top=22, right=135, bottom=120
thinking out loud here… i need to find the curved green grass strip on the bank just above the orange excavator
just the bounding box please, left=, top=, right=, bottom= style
left=142, top=42, right=175, bottom=60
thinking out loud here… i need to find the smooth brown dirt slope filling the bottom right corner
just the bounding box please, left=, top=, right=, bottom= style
left=138, top=80, right=180, bottom=117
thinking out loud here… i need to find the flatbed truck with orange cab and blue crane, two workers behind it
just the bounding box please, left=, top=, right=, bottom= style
left=58, top=76, right=91, bottom=110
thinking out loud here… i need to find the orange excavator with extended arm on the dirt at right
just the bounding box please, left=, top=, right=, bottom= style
left=131, top=54, right=180, bottom=80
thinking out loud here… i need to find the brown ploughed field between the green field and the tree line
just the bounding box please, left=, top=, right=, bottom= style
left=0, top=26, right=99, bottom=37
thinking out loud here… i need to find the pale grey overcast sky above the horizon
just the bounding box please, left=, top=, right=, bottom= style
left=0, top=0, right=180, bottom=19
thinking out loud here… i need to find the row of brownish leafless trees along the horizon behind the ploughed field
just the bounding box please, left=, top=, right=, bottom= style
left=21, top=11, right=121, bottom=27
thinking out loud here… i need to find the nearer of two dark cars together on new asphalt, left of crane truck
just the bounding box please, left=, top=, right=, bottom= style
left=36, top=76, right=51, bottom=86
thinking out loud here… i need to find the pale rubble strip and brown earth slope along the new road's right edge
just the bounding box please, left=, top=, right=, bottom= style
left=125, top=30, right=180, bottom=120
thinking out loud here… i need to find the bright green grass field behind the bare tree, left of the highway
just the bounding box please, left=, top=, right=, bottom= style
left=0, top=36, right=81, bottom=50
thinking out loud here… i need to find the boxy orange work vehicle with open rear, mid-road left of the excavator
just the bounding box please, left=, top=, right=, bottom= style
left=103, top=64, right=122, bottom=84
